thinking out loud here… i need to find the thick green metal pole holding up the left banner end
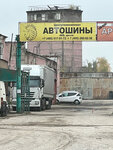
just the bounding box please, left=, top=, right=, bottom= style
left=16, top=35, right=21, bottom=113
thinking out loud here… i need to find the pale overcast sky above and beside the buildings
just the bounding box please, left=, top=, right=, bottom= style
left=0, top=0, right=113, bottom=71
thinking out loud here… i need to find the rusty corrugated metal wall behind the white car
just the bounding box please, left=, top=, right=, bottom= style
left=60, top=77, right=113, bottom=99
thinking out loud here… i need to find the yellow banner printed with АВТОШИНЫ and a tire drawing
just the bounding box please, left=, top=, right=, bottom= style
left=20, top=22, right=96, bottom=42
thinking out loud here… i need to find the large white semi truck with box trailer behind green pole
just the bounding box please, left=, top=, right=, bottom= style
left=12, top=65, right=55, bottom=110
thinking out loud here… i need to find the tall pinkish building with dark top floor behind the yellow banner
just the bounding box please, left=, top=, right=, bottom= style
left=27, top=6, right=82, bottom=72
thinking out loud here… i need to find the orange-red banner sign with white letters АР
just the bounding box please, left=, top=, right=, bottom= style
left=97, top=22, right=113, bottom=41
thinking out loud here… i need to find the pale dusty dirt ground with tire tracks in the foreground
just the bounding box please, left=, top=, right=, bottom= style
left=0, top=100, right=113, bottom=150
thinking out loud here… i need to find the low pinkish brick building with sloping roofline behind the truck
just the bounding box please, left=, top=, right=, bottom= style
left=0, top=34, right=60, bottom=91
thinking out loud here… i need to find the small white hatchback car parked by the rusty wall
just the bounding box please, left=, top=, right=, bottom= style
left=56, top=91, right=82, bottom=104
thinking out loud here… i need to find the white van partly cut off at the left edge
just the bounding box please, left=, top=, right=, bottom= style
left=0, top=81, right=8, bottom=116
